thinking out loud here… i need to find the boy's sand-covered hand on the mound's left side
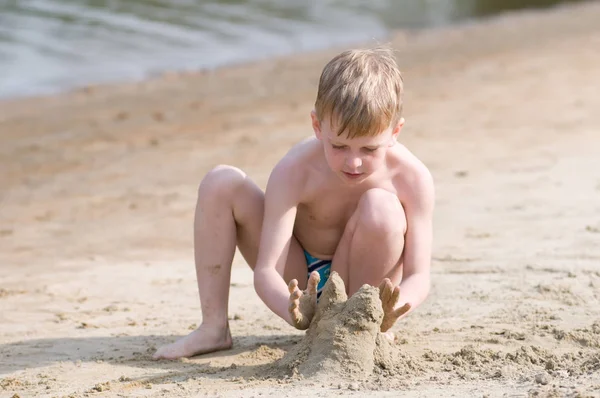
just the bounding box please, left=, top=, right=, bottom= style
left=288, top=271, right=321, bottom=330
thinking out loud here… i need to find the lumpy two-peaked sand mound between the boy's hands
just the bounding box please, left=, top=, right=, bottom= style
left=275, top=272, right=420, bottom=380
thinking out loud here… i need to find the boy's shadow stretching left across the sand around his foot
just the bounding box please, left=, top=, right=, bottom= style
left=0, top=335, right=301, bottom=382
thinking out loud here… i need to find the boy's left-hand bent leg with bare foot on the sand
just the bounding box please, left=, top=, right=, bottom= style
left=154, top=166, right=306, bottom=359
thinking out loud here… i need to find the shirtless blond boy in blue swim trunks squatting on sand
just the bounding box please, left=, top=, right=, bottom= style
left=154, top=49, right=434, bottom=359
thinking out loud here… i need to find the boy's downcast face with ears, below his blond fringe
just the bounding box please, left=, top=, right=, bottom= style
left=311, top=111, right=404, bottom=184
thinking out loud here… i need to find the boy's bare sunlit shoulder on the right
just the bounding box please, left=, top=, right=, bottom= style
left=391, top=144, right=435, bottom=209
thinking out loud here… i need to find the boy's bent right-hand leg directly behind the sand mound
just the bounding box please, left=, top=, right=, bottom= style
left=331, top=188, right=406, bottom=295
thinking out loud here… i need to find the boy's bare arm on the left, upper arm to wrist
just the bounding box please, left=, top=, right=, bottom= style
left=254, top=161, right=301, bottom=325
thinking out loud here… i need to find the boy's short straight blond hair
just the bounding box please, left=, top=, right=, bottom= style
left=315, top=47, right=404, bottom=138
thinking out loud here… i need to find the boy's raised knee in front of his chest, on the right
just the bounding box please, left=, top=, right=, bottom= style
left=358, top=188, right=406, bottom=236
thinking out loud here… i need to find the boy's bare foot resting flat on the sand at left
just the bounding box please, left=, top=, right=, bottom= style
left=152, top=325, right=232, bottom=359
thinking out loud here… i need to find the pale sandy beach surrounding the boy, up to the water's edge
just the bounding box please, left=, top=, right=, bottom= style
left=0, top=3, right=600, bottom=397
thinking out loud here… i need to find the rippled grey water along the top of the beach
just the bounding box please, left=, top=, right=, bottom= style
left=0, top=0, right=578, bottom=97
